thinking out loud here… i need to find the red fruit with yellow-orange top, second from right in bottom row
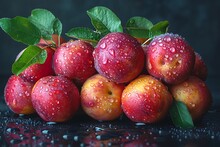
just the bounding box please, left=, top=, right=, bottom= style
left=121, top=75, right=173, bottom=123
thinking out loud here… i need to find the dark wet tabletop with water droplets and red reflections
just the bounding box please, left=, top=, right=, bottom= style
left=0, top=97, right=220, bottom=147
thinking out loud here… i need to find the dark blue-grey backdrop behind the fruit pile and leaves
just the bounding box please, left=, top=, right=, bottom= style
left=0, top=0, right=220, bottom=105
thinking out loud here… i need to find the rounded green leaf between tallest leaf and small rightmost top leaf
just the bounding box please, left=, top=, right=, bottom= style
left=126, top=16, right=153, bottom=38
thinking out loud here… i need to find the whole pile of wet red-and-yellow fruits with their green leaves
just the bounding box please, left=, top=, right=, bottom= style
left=0, top=7, right=212, bottom=127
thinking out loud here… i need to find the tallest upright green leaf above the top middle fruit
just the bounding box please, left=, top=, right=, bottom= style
left=87, top=6, right=123, bottom=34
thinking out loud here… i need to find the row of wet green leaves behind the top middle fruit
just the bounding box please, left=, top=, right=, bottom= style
left=66, top=6, right=169, bottom=45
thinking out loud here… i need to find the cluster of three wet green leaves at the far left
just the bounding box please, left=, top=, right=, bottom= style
left=0, top=9, right=62, bottom=75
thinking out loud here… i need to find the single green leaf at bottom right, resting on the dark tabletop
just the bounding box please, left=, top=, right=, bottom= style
left=170, top=101, right=194, bottom=129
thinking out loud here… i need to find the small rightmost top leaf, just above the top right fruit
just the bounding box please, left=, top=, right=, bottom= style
left=149, top=20, right=169, bottom=38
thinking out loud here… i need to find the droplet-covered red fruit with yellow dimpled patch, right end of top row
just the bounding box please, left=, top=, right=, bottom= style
left=146, top=33, right=195, bottom=84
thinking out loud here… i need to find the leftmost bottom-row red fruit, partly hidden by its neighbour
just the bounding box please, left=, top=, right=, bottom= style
left=4, top=75, right=35, bottom=114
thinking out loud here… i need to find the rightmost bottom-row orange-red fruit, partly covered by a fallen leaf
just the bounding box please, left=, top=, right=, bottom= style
left=170, top=76, right=212, bottom=121
